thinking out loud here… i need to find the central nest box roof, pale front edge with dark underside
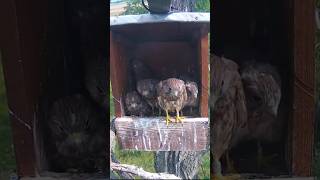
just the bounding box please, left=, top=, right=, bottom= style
left=110, top=12, right=210, bottom=41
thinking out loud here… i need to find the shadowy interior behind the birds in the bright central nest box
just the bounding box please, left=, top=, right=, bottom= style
left=111, top=23, right=207, bottom=116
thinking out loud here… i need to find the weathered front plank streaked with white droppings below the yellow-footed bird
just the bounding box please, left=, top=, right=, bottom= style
left=115, top=117, right=209, bottom=151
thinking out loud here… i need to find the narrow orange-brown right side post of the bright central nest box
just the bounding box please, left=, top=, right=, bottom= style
left=199, top=33, right=209, bottom=117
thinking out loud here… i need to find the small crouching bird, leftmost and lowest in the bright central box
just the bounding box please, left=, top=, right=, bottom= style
left=125, top=91, right=151, bottom=116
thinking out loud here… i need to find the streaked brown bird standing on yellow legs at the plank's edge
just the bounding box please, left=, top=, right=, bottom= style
left=157, top=78, right=188, bottom=125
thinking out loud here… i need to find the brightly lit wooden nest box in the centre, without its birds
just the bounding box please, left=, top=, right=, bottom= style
left=110, top=13, right=210, bottom=151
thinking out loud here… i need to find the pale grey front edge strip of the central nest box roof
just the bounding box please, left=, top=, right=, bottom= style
left=110, top=12, right=210, bottom=26
